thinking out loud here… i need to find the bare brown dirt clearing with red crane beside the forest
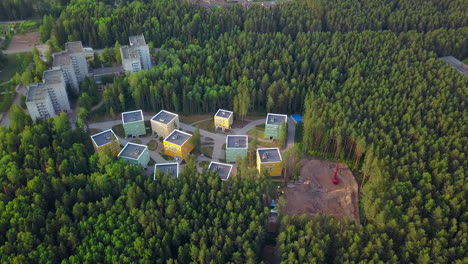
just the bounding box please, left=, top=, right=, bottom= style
left=284, top=158, right=359, bottom=224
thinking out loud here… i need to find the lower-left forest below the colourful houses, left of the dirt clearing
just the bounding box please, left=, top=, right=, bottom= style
left=0, top=107, right=269, bottom=263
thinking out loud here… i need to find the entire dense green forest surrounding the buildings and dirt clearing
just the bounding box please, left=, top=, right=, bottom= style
left=0, top=0, right=468, bottom=263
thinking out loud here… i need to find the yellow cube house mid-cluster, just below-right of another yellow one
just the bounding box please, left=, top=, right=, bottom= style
left=163, top=129, right=193, bottom=159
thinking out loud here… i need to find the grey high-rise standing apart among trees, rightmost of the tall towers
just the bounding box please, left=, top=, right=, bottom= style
left=120, top=35, right=151, bottom=73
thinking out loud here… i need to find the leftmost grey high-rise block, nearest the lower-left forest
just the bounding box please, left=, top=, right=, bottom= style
left=26, top=70, right=70, bottom=120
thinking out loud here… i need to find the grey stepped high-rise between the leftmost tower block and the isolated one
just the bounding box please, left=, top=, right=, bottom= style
left=52, top=41, right=89, bottom=93
